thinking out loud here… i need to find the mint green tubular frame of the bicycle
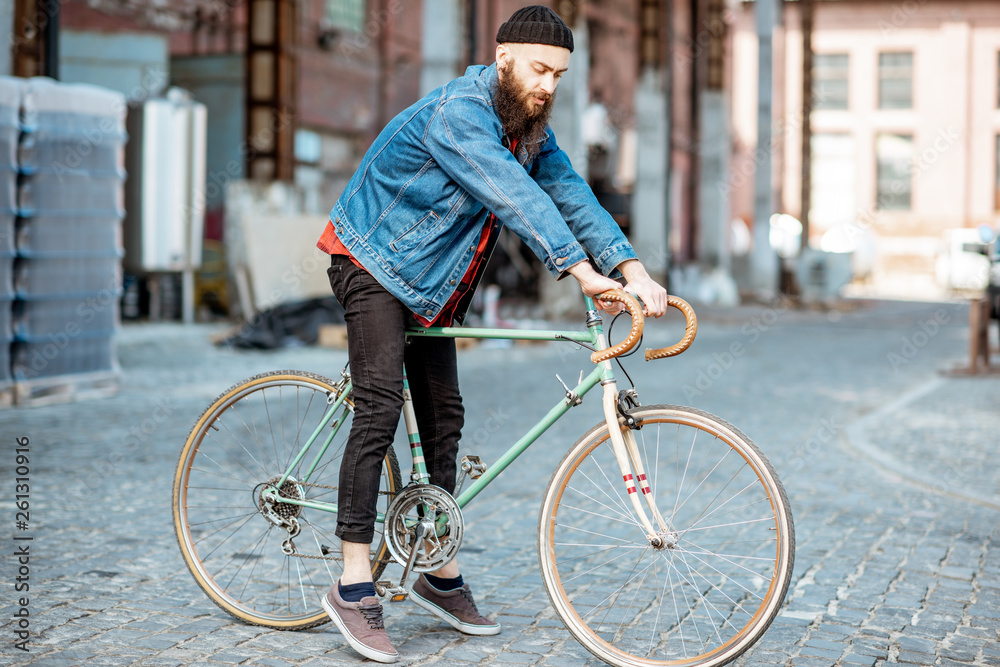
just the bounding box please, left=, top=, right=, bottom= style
left=264, top=297, right=615, bottom=523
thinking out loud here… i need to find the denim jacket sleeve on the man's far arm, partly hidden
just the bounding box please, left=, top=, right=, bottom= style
left=531, top=130, right=636, bottom=276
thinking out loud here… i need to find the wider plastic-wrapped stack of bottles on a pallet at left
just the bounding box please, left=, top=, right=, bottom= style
left=11, top=78, right=127, bottom=393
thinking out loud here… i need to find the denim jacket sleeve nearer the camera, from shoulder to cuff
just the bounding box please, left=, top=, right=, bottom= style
left=424, top=97, right=587, bottom=277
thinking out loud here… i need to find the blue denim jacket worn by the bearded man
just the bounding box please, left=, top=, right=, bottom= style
left=330, top=63, right=636, bottom=319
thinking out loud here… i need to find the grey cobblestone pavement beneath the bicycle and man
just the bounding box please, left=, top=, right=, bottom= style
left=0, top=302, right=1000, bottom=667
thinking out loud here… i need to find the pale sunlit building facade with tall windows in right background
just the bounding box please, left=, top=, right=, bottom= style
left=731, top=0, right=1000, bottom=298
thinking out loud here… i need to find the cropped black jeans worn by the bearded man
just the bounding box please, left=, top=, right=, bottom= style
left=327, top=255, right=465, bottom=544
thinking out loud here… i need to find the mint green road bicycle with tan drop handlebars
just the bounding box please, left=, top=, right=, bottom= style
left=173, top=290, right=795, bottom=666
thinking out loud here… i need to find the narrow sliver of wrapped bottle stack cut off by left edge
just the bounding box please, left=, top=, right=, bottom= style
left=0, top=77, right=24, bottom=405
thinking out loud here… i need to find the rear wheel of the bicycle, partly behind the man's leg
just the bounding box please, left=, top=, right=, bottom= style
left=173, top=371, right=402, bottom=630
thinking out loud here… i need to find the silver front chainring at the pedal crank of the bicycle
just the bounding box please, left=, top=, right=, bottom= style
left=385, top=484, right=465, bottom=572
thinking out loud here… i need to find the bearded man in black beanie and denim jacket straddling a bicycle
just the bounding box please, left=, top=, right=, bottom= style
left=318, top=6, right=667, bottom=662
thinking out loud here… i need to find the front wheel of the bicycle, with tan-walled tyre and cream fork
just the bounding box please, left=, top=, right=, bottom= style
left=538, top=405, right=795, bottom=667
